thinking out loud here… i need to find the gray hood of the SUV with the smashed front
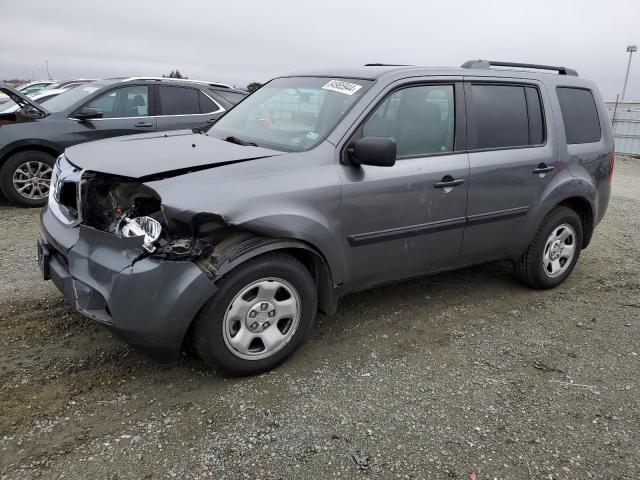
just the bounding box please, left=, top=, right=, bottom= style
left=65, top=130, right=285, bottom=178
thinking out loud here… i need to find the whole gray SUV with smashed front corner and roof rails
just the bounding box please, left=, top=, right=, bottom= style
left=38, top=61, right=614, bottom=374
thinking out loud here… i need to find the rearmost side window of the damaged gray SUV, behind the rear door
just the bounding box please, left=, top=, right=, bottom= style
left=556, top=87, right=602, bottom=144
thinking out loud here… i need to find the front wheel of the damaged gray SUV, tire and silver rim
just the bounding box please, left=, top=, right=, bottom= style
left=193, top=253, right=317, bottom=375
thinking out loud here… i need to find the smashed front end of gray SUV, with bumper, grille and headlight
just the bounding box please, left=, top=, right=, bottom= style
left=38, top=156, right=222, bottom=362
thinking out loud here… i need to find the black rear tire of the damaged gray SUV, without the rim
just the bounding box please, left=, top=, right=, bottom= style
left=516, top=206, right=583, bottom=290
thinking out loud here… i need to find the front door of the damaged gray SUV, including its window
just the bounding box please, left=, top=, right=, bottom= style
left=342, top=82, right=469, bottom=289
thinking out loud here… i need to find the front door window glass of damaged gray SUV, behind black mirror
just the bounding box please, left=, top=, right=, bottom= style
left=362, top=85, right=455, bottom=157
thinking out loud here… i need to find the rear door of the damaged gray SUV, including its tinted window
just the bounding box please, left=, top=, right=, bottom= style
left=461, top=78, right=558, bottom=263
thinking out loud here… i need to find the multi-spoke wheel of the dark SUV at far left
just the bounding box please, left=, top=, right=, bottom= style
left=0, top=150, right=56, bottom=207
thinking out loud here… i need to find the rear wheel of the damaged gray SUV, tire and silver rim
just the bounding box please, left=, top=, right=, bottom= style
left=516, top=207, right=583, bottom=289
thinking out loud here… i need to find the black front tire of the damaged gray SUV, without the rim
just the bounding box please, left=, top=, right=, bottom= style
left=193, top=253, right=318, bottom=375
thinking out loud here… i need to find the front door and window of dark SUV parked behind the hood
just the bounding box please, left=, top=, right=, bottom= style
left=71, top=85, right=156, bottom=141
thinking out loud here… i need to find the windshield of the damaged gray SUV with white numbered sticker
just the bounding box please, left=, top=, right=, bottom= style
left=208, top=77, right=372, bottom=151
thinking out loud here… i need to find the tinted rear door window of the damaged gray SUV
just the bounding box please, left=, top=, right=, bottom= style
left=471, top=84, right=544, bottom=148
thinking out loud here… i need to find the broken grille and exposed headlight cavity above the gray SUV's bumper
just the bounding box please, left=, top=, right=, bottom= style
left=49, top=155, right=224, bottom=261
